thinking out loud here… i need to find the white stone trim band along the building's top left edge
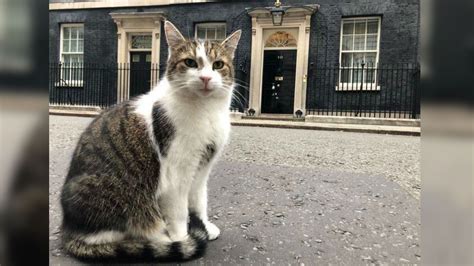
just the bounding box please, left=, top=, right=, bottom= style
left=49, top=0, right=211, bottom=10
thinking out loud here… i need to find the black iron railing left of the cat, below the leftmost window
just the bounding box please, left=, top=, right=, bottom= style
left=49, top=63, right=165, bottom=108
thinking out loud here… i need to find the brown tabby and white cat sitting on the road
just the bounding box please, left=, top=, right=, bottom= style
left=61, top=21, right=241, bottom=260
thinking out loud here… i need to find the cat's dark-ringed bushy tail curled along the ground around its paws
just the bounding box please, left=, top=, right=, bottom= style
left=64, top=215, right=208, bottom=261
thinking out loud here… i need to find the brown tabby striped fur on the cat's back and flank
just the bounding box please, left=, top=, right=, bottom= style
left=63, top=104, right=160, bottom=234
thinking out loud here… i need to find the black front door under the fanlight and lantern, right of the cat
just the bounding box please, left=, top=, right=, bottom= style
left=262, top=50, right=296, bottom=114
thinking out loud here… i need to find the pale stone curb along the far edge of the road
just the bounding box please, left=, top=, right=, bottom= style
left=49, top=109, right=421, bottom=136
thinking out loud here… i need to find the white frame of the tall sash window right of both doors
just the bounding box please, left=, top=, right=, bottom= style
left=336, top=16, right=382, bottom=91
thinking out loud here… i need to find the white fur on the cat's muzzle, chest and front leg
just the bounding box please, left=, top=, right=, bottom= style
left=135, top=43, right=232, bottom=243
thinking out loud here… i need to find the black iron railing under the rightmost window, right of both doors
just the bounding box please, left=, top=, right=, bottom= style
left=306, top=64, right=420, bottom=119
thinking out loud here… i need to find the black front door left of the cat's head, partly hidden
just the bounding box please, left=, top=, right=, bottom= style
left=130, top=52, right=151, bottom=98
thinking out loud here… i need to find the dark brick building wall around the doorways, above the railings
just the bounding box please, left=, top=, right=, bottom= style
left=49, top=0, right=420, bottom=109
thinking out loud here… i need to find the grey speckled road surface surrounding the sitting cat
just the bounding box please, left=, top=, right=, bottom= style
left=50, top=116, right=421, bottom=265
